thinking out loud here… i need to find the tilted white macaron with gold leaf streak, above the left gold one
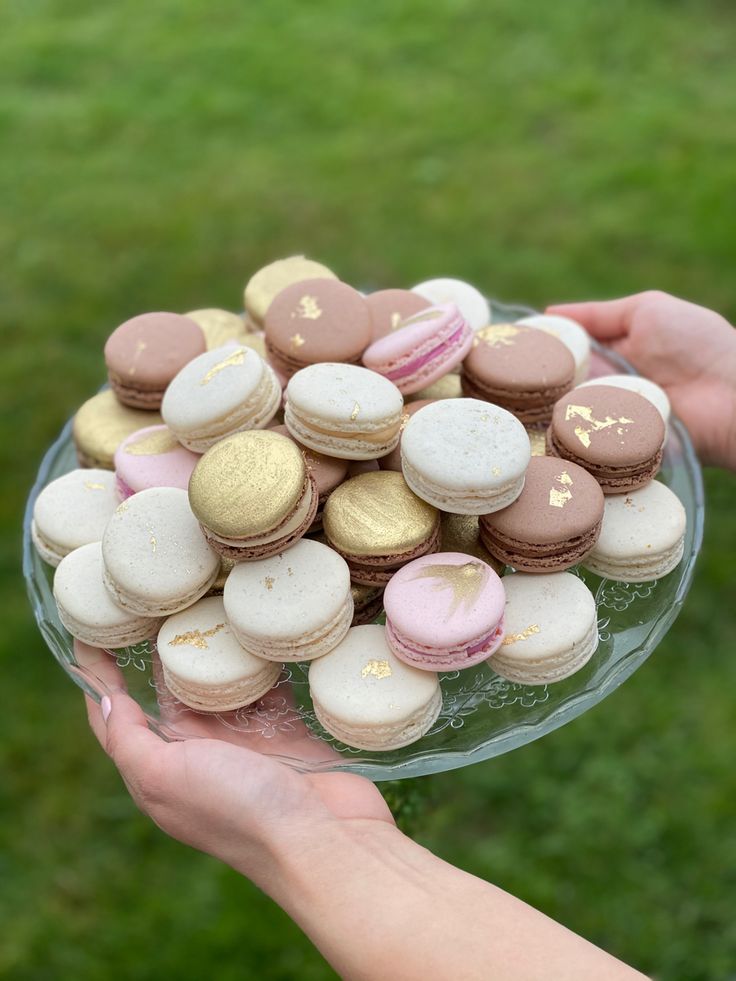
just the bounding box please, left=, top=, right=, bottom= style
left=161, top=344, right=281, bottom=453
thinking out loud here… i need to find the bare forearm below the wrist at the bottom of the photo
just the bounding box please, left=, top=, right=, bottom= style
left=243, top=821, right=641, bottom=981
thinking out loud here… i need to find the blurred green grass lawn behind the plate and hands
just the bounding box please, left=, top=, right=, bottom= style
left=0, top=0, right=736, bottom=981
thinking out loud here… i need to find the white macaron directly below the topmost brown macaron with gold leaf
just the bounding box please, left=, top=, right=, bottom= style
left=284, top=363, right=404, bottom=460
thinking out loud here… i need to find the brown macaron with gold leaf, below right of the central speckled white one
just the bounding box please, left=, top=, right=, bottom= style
left=480, top=456, right=604, bottom=572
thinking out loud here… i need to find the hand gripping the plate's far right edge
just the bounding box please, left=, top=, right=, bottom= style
left=546, top=290, right=736, bottom=470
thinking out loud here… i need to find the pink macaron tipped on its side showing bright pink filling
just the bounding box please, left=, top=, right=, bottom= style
left=363, top=303, right=473, bottom=395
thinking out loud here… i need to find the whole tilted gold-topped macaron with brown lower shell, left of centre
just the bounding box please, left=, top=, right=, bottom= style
left=189, top=429, right=318, bottom=562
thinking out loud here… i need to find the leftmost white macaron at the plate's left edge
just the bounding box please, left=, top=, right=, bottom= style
left=31, top=470, right=120, bottom=566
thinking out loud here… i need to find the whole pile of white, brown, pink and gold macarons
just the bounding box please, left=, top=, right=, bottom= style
left=32, top=256, right=685, bottom=750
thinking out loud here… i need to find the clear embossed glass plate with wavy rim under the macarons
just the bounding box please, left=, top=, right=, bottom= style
left=23, top=303, right=704, bottom=780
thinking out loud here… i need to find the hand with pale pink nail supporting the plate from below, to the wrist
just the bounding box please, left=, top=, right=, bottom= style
left=80, top=645, right=394, bottom=895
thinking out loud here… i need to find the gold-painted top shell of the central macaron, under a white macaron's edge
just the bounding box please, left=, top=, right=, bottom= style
left=322, top=470, right=439, bottom=558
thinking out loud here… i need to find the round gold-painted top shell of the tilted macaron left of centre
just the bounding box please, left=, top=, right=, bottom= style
left=189, top=429, right=308, bottom=539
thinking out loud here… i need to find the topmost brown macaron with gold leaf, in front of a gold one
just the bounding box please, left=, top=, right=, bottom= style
left=264, top=279, right=371, bottom=378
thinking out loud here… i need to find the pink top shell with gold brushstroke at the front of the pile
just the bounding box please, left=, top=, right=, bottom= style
left=383, top=552, right=506, bottom=650
